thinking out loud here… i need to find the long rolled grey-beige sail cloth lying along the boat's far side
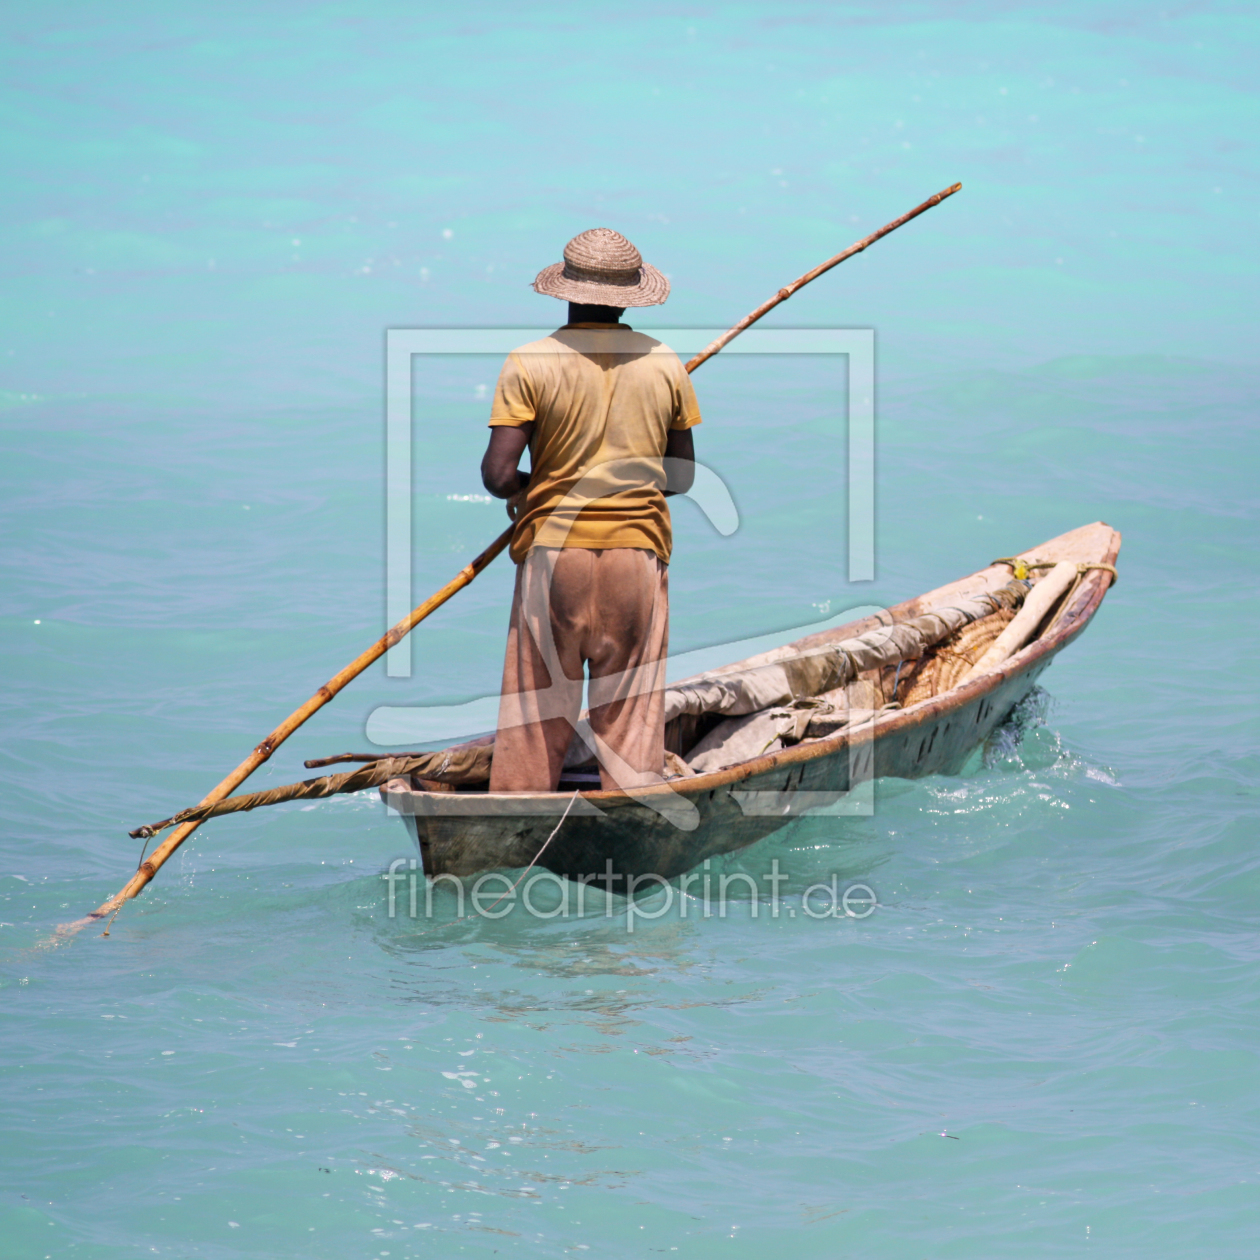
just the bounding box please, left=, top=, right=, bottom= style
left=665, top=580, right=1029, bottom=722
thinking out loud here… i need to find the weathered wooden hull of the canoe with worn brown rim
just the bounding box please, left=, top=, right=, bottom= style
left=381, top=522, right=1120, bottom=891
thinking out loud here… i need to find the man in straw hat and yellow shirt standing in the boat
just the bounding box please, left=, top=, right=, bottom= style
left=481, top=228, right=701, bottom=793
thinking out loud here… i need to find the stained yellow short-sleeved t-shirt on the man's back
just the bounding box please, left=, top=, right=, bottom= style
left=490, top=324, right=701, bottom=564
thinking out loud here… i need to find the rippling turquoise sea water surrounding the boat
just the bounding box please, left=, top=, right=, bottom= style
left=0, top=3, right=1260, bottom=1260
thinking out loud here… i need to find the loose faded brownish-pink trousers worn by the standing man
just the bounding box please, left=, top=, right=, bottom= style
left=490, top=547, right=669, bottom=791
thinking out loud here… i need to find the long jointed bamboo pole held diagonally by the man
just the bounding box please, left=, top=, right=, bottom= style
left=58, top=177, right=963, bottom=935
